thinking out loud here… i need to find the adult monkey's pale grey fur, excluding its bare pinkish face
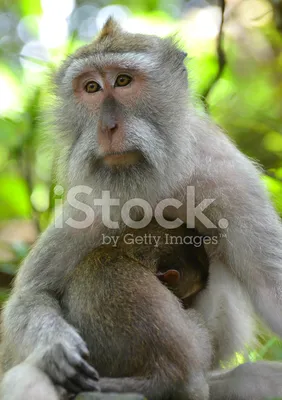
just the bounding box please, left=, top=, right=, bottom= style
left=0, top=20, right=282, bottom=400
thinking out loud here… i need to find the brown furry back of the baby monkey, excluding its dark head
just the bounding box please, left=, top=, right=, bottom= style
left=62, top=225, right=209, bottom=381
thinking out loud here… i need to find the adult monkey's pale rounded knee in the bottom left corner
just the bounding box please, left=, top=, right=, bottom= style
left=0, top=363, right=66, bottom=400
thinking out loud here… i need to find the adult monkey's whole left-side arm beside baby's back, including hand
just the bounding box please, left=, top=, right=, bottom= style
left=3, top=208, right=103, bottom=391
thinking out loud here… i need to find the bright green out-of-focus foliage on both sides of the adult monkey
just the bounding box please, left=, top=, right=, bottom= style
left=0, top=0, right=282, bottom=363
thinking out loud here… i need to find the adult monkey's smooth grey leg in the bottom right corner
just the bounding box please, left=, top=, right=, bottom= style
left=209, top=361, right=282, bottom=400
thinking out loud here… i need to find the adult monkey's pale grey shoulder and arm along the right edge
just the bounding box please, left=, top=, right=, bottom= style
left=186, top=122, right=282, bottom=336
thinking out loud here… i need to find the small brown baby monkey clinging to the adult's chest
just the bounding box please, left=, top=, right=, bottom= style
left=61, top=223, right=211, bottom=400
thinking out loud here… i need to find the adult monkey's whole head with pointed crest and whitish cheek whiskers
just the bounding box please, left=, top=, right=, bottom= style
left=55, top=19, right=187, bottom=191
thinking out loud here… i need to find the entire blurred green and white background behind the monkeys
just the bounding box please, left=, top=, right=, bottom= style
left=0, top=0, right=282, bottom=362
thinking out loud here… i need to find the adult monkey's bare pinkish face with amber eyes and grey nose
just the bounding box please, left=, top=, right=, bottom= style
left=72, top=65, right=153, bottom=168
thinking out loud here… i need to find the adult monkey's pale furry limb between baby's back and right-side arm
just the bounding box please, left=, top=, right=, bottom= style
left=193, top=261, right=254, bottom=368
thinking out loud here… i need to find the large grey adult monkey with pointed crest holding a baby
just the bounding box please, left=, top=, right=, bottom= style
left=0, top=21, right=282, bottom=399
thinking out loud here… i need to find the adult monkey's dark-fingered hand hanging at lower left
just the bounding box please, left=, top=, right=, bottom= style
left=27, top=328, right=100, bottom=393
